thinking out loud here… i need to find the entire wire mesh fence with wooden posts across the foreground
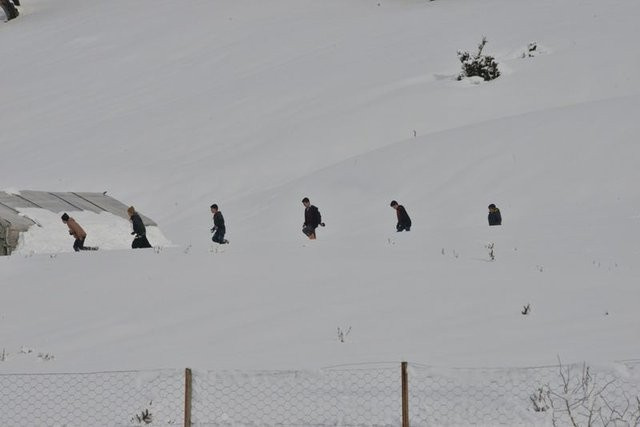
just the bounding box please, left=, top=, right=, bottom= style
left=0, top=361, right=640, bottom=427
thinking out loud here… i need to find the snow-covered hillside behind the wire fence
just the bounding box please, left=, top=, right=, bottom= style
left=0, top=0, right=640, bottom=382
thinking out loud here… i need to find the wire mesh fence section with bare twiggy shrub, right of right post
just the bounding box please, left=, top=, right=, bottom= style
left=409, top=362, right=640, bottom=427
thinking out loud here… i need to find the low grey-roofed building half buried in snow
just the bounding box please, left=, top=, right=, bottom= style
left=0, top=190, right=157, bottom=255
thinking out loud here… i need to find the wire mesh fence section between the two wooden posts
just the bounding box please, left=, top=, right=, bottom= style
left=192, top=364, right=402, bottom=426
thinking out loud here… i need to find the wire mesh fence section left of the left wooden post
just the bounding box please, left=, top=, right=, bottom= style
left=0, top=370, right=184, bottom=427
